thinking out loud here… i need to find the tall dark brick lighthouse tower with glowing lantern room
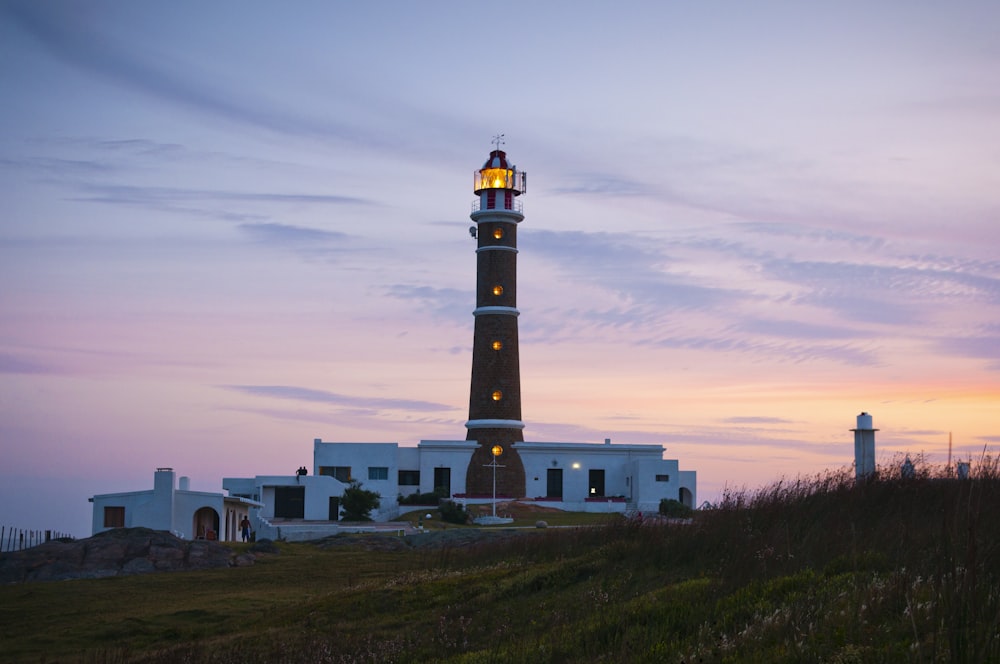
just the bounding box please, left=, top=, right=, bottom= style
left=465, top=139, right=525, bottom=498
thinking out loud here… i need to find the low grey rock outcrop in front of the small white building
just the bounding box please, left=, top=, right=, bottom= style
left=0, top=528, right=254, bottom=583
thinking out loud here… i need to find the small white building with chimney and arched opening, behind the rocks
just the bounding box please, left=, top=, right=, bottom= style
left=90, top=468, right=260, bottom=541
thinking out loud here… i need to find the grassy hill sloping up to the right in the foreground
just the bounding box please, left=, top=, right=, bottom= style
left=0, top=459, right=1000, bottom=663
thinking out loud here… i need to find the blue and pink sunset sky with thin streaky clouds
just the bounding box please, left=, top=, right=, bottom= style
left=0, top=0, right=1000, bottom=536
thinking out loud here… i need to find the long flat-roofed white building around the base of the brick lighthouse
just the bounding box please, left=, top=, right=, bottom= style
left=215, top=438, right=697, bottom=540
